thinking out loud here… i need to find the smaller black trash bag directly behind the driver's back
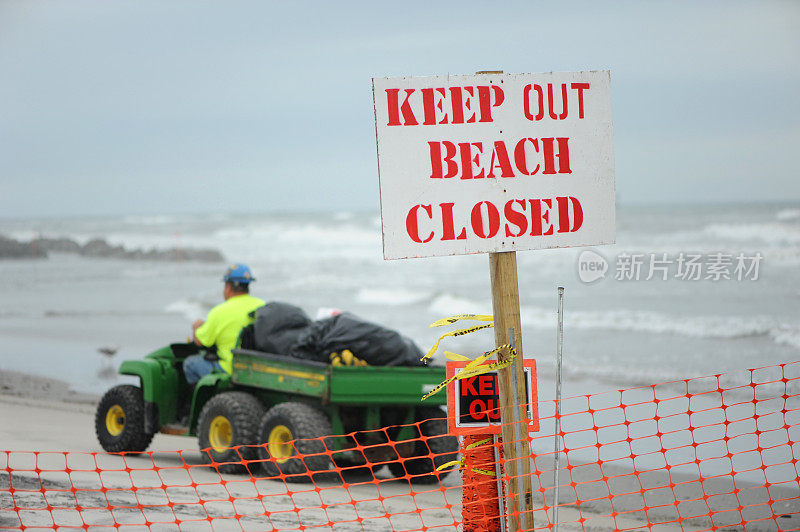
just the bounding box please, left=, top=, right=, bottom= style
left=239, top=301, right=311, bottom=356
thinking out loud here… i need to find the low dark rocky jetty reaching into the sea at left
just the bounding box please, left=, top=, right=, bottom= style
left=0, top=235, right=225, bottom=262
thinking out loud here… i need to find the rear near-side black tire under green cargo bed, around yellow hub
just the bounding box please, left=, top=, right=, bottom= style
left=258, top=402, right=333, bottom=482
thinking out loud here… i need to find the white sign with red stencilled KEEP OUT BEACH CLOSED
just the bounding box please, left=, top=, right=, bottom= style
left=372, top=71, right=616, bottom=259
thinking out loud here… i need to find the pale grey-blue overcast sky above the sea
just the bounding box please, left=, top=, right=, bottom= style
left=0, top=0, right=800, bottom=217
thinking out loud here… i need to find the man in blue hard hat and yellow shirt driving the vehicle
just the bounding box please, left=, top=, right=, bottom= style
left=183, top=264, right=264, bottom=385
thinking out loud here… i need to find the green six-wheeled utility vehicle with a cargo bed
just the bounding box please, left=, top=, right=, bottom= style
left=95, top=344, right=458, bottom=482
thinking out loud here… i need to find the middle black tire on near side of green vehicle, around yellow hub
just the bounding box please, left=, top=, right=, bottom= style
left=197, top=392, right=264, bottom=473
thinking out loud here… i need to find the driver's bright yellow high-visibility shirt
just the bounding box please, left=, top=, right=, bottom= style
left=194, top=294, right=264, bottom=373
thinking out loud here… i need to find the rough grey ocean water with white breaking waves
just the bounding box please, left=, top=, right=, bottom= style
left=0, top=204, right=800, bottom=397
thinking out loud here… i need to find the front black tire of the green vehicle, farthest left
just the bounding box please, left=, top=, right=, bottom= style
left=94, top=384, right=153, bottom=453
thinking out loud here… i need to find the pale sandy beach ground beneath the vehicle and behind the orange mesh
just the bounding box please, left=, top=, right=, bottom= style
left=0, top=372, right=800, bottom=530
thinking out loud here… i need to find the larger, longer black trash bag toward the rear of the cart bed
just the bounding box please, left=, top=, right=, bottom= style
left=291, top=312, right=423, bottom=366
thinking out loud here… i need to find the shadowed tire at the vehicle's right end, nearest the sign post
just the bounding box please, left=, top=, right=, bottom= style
left=389, top=406, right=458, bottom=484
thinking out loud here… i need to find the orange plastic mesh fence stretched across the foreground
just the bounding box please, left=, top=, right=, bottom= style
left=0, top=362, right=800, bottom=531
